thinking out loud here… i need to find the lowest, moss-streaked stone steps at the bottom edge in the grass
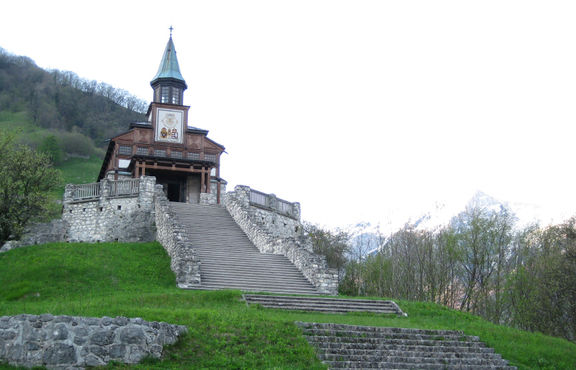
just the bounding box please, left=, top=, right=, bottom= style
left=296, top=322, right=516, bottom=369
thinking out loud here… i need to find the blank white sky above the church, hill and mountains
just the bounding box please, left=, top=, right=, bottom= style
left=0, top=0, right=576, bottom=227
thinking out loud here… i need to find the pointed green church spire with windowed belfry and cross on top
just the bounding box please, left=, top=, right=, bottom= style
left=150, top=27, right=188, bottom=105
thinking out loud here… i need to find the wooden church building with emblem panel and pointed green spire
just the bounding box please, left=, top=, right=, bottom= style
left=98, top=38, right=225, bottom=203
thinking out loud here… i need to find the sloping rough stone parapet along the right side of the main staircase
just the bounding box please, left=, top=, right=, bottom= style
left=224, top=186, right=338, bottom=295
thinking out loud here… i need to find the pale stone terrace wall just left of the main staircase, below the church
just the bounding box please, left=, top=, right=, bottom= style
left=62, top=176, right=156, bottom=242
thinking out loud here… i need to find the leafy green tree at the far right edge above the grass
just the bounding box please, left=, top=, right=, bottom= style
left=505, top=218, right=576, bottom=341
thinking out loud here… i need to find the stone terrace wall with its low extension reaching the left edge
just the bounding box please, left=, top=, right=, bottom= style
left=0, top=176, right=156, bottom=253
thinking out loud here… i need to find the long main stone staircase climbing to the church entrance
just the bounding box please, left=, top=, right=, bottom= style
left=170, top=202, right=318, bottom=295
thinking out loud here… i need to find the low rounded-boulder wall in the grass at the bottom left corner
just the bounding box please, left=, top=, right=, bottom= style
left=0, top=314, right=187, bottom=369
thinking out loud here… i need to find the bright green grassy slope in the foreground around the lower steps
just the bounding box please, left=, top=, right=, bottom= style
left=0, top=243, right=576, bottom=369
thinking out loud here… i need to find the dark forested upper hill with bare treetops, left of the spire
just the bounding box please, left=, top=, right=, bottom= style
left=0, top=48, right=147, bottom=148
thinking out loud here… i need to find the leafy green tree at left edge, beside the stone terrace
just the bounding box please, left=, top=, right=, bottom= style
left=0, top=133, right=60, bottom=244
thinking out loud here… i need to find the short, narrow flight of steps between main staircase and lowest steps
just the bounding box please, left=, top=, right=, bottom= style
left=243, top=294, right=404, bottom=315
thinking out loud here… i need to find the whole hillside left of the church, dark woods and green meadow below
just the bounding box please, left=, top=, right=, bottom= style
left=0, top=48, right=147, bottom=220
